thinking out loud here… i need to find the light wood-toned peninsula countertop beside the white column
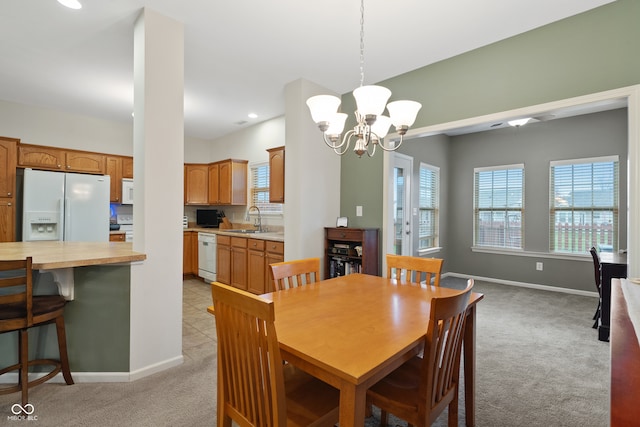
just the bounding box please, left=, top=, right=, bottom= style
left=0, top=241, right=147, bottom=270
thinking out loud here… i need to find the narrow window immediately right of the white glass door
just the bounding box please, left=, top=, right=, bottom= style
left=418, top=163, right=440, bottom=250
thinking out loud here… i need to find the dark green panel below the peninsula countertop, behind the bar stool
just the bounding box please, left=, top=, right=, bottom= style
left=0, top=265, right=131, bottom=374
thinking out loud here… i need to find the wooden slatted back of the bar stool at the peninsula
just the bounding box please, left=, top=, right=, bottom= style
left=0, top=257, right=33, bottom=332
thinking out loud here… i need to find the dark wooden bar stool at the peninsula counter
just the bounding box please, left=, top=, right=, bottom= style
left=0, top=257, right=73, bottom=411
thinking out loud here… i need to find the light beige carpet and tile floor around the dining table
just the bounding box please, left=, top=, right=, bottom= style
left=0, top=278, right=609, bottom=427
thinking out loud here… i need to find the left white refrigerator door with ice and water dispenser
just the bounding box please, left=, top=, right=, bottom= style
left=22, top=169, right=65, bottom=242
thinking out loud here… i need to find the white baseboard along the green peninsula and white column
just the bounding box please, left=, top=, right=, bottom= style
left=0, top=355, right=184, bottom=384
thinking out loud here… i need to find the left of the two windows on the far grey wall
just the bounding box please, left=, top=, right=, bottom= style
left=473, top=164, right=524, bottom=249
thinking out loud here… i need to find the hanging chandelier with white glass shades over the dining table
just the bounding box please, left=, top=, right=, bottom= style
left=307, top=0, right=422, bottom=157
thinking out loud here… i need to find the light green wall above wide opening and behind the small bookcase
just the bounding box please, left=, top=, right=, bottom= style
left=340, top=0, right=640, bottom=286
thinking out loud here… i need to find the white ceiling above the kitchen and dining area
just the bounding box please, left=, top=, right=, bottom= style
left=0, top=0, right=612, bottom=139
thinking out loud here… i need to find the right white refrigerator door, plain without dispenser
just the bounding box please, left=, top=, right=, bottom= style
left=64, top=173, right=110, bottom=242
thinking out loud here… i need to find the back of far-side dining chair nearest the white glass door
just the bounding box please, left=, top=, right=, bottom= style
left=387, top=254, right=443, bottom=286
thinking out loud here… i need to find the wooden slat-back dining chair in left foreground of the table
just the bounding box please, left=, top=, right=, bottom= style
left=211, top=282, right=340, bottom=427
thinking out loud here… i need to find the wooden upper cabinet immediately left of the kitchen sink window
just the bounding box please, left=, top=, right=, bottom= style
left=208, top=159, right=249, bottom=205
